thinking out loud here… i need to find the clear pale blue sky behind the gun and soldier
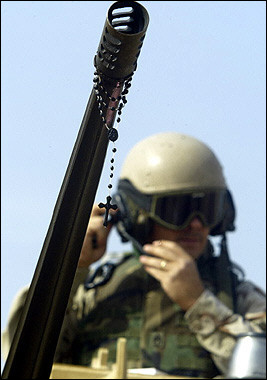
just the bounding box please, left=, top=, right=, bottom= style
left=1, top=1, right=266, bottom=368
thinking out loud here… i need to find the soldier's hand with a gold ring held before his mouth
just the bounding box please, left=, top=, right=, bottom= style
left=140, top=240, right=204, bottom=310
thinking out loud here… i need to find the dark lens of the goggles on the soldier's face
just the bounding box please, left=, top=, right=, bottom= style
left=154, top=190, right=225, bottom=227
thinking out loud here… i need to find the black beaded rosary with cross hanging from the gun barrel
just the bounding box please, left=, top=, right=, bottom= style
left=93, top=71, right=133, bottom=227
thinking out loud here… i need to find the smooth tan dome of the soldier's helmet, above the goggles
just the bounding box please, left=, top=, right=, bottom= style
left=120, top=132, right=227, bottom=194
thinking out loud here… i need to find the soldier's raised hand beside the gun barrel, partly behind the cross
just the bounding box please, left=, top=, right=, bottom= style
left=78, top=204, right=114, bottom=268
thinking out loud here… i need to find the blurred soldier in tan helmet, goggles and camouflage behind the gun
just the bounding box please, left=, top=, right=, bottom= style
left=3, top=132, right=266, bottom=378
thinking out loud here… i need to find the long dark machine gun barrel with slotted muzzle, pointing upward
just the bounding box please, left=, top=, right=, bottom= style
left=2, top=1, right=149, bottom=379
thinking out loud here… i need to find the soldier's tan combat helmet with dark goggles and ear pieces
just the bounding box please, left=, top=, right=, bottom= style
left=114, top=132, right=235, bottom=244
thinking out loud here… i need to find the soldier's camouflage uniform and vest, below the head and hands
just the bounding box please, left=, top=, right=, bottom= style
left=1, top=243, right=265, bottom=378
